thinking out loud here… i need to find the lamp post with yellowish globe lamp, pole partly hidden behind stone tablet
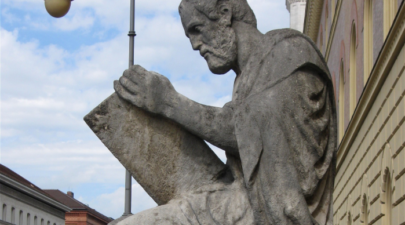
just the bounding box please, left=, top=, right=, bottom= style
left=45, top=0, right=136, bottom=217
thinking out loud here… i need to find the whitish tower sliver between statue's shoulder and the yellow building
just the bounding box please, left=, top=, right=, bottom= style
left=285, top=0, right=307, bottom=32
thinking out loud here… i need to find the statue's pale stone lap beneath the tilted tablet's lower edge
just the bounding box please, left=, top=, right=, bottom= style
left=118, top=180, right=254, bottom=225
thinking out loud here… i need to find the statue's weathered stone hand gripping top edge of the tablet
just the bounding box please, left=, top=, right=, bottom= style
left=114, top=65, right=177, bottom=114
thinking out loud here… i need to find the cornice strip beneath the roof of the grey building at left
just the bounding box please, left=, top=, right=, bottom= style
left=0, top=174, right=72, bottom=212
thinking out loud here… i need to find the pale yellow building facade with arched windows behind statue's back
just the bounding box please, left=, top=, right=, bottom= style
left=304, top=0, right=405, bottom=225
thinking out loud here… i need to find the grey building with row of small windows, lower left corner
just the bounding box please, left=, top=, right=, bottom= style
left=0, top=164, right=71, bottom=225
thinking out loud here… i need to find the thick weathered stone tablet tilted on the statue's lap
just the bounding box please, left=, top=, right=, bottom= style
left=84, top=93, right=225, bottom=205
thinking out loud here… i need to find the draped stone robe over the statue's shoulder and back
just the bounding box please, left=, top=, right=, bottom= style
left=234, top=29, right=337, bottom=225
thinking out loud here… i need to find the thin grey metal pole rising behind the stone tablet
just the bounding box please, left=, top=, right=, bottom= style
left=123, top=0, right=136, bottom=216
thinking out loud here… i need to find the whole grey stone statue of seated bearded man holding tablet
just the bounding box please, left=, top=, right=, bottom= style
left=85, top=0, right=337, bottom=225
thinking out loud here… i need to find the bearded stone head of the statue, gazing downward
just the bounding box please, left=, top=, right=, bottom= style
left=179, top=0, right=256, bottom=74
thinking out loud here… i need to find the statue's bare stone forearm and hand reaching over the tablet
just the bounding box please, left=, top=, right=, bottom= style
left=114, top=65, right=237, bottom=154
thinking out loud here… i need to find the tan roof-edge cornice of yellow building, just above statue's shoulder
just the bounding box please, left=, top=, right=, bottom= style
left=304, top=0, right=324, bottom=42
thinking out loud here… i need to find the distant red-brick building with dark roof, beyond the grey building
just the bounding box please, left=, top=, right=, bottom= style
left=44, top=190, right=113, bottom=225
